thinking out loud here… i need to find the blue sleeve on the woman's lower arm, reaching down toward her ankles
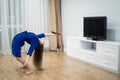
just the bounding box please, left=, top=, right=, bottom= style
left=27, top=39, right=40, bottom=56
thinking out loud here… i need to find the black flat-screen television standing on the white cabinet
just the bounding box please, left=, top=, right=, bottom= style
left=83, top=16, right=107, bottom=40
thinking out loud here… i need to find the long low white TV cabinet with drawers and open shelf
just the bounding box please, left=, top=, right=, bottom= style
left=66, top=37, right=120, bottom=73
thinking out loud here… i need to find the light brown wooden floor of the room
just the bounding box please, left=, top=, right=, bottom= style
left=0, top=52, right=120, bottom=80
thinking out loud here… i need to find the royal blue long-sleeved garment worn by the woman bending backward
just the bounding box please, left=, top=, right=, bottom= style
left=12, top=31, right=45, bottom=57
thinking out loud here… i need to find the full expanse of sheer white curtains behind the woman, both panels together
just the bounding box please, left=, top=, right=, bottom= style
left=0, top=0, right=49, bottom=54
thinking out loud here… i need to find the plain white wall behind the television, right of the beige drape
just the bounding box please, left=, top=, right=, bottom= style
left=61, top=0, right=120, bottom=51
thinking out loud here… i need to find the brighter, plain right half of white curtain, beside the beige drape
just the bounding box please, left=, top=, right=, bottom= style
left=25, top=0, right=49, bottom=34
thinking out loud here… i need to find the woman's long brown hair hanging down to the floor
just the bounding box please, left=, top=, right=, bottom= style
left=33, top=45, right=43, bottom=69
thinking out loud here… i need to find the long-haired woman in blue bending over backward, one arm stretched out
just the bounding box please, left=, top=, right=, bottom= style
left=12, top=31, right=59, bottom=74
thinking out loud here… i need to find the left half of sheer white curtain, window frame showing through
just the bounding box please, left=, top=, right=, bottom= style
left=0, top=0, right=24, bottom=54
